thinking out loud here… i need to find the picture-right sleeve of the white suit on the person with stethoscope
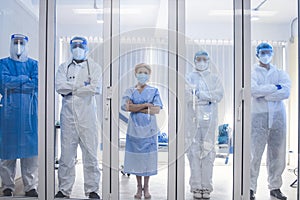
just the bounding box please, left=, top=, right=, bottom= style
left=74, top=62, right=102, bottom=96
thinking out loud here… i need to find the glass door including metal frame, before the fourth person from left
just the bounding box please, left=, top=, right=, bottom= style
left=177, top=1, right=250, bottom=199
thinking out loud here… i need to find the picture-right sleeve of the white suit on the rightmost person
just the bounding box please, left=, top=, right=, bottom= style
left=265, top=71, right=291, bottom=101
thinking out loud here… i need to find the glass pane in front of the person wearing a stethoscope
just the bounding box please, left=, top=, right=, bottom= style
left=53, top=0, right=103, bottom=199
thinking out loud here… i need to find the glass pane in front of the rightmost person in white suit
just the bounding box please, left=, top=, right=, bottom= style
left=250, top=0, right=299, bottom=199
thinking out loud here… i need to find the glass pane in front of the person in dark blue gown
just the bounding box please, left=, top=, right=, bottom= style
left=0, top=0, right=39, bottom=197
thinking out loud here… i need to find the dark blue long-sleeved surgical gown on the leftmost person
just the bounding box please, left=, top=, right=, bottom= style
left=0, top=58, right=38, bottom=159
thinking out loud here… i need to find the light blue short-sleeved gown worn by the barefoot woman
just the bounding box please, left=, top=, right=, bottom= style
left=122, top=86, right=163, bottom=176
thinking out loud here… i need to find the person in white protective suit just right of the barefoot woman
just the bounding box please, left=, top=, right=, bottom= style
left=186, top=51, right=224, bottom=199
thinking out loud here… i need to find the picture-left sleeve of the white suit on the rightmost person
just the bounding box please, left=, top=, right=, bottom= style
left=251, top=72, right=277, bottom=98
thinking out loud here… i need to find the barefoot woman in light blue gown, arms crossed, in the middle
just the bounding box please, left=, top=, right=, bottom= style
left=122, top=63, right=163, bottom=199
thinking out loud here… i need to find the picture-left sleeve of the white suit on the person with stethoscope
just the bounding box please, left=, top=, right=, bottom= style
left=55, top=64, right=76, bottom=95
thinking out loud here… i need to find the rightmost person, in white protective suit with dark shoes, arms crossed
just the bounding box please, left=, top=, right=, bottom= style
left=250, top=43, right=291, bottom=200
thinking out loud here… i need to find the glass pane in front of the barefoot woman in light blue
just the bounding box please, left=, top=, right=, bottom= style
left=112, top=0, right=174, bottom=199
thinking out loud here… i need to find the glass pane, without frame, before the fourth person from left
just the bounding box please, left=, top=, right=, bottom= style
left=182, top=0, right=234, bottom=199
